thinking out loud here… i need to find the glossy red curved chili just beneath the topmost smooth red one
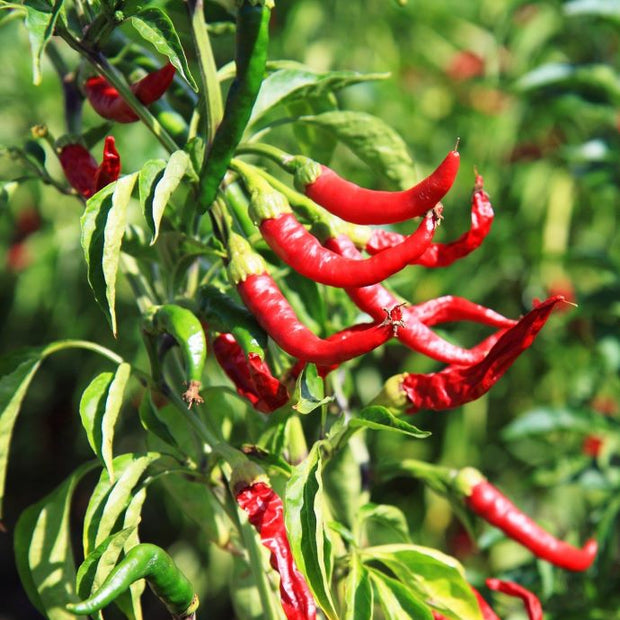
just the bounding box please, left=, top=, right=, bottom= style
left=260, top=213, right=437, bottom=288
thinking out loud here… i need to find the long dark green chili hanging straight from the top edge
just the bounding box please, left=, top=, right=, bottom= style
left=199, top=0, right=273, bottom=212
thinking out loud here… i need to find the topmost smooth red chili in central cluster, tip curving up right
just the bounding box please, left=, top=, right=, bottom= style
left=297, top=151, right=460, bottom=224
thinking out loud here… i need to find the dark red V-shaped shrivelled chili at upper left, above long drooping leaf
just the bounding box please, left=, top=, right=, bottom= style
left=58, top=136, right=121, bottom=198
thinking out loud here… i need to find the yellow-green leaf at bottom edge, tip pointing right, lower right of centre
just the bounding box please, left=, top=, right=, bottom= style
left=361, top=544, right=482, bottom=620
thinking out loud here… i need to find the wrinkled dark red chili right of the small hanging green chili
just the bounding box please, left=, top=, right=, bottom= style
left=213, top=334, right=289, bottom=413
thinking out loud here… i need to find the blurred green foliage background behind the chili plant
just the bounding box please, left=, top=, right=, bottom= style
left=0, top=0, right=620, bottom=620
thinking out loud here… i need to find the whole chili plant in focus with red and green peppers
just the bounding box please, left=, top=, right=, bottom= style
left=0, top=0, right=598, bottom=620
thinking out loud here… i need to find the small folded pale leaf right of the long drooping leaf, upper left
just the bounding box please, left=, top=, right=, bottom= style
left=138, top=151, right=190, bottom=245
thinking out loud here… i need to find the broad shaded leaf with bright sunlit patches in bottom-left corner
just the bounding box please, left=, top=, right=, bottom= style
left=14, top=463, right=95, bottom=620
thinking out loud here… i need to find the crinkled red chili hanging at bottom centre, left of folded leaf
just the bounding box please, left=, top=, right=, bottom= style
left=235, top=482, right=316, bottom=620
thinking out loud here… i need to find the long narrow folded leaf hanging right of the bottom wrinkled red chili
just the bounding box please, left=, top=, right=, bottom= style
left=285, top=442, right=338, bottom=620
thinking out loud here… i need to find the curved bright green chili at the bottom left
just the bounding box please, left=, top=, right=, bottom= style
left=67, top=543, right=198, bottom=619
